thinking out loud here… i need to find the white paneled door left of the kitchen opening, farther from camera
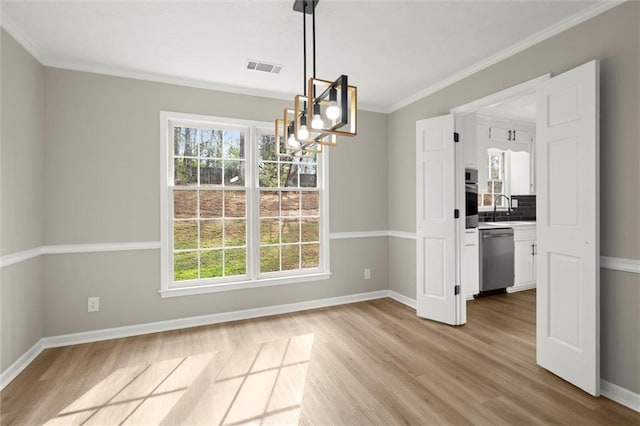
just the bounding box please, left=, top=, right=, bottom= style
left=416, top=115, right=466, bottom=325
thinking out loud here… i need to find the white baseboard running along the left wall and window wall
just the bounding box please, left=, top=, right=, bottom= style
left=0, top=290, right=389, bottom=390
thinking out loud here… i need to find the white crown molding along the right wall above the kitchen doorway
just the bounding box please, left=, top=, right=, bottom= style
left=387, top=0, right=627, bottom=113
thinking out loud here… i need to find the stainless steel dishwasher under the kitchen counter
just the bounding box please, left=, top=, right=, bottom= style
left=479, top=228, right=514, bottom=292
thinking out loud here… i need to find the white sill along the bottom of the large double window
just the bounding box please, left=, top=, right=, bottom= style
left=158, top=272, right=331, bottom=298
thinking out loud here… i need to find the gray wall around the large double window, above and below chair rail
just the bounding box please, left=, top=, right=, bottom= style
left=44, top=68, right=388, bottom=336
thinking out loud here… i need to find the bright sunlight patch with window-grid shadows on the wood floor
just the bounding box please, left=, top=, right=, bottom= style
left=46, top=334, right=314, bottom=425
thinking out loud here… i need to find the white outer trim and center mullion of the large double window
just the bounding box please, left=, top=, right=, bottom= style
left=159, top=111, right=331, bottom=298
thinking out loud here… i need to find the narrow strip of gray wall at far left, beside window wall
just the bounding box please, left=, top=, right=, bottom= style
left=0, top=30, right=44, bottom=371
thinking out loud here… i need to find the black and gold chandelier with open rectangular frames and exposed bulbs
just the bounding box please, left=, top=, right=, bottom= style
left=275, top=0, right=358, bottom=158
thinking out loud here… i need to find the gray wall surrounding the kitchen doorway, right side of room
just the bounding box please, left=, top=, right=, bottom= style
left=388, top=2, right=640, bottom=393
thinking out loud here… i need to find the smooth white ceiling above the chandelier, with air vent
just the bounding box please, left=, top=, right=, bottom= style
left=2, top=0, right=612, bottom=112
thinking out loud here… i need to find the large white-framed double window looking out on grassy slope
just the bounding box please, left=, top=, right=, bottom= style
left=161, top=113, right=328, bottom=295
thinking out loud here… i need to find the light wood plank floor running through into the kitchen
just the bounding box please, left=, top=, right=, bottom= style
left=0, top=291, right=640, bottom=425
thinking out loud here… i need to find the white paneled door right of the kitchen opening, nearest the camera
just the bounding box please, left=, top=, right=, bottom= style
left=536, top=61, right=600, bottom=395
